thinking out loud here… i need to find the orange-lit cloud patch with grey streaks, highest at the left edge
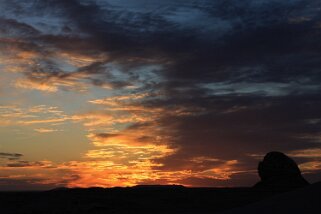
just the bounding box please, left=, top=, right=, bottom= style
left=0, top=38, right=112, bottom=93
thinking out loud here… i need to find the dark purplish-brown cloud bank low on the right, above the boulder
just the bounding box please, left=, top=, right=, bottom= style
left=150, top=95, right=321, bottom=169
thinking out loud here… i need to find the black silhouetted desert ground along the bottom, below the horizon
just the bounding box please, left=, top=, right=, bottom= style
left=0, top=184, right=321, bottom=214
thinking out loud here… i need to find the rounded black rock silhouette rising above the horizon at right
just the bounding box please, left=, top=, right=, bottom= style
left=254, top=152, right=309, bottom=189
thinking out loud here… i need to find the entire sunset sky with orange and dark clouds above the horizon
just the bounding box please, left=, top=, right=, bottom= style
left=0, top=0, right=321, bottom=190
